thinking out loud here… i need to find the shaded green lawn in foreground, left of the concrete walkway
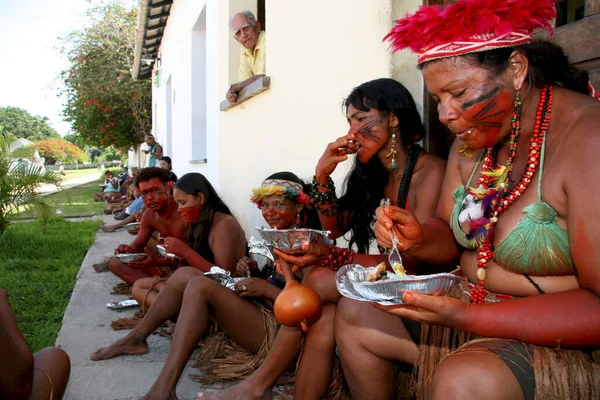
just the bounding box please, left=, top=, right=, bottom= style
left=0, top=219, right=100, bottom=352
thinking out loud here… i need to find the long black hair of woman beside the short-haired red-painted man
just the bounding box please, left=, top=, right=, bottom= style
left=173, top=170, right=233, bottom=250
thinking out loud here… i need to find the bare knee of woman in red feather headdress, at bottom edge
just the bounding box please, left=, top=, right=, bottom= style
left=432, top=342, right=534, bottom=400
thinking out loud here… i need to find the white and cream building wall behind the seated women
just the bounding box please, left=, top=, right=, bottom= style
left=153, top=0, right=422, bottom=247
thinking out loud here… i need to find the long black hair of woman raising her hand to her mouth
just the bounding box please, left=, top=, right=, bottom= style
left=338, top=78, right=425, bottom=253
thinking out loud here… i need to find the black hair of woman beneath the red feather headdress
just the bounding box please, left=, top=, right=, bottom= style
left=442, top=40, right=589, bottom=95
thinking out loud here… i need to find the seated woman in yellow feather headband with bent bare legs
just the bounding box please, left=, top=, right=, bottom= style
left=90, top=172, right=319, bottom=399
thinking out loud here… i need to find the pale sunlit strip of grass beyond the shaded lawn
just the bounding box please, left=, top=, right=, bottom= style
left=16, top=179, right=105, bottom=219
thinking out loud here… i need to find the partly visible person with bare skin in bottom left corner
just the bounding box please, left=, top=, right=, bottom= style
left=0, top=289, right=71, bottom=400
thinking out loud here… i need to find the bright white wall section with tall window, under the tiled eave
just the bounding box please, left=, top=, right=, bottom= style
left=152, top=0, right=218, bottom=182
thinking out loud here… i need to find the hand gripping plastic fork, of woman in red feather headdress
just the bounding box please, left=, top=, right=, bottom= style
left=375, top=206, right=424, bottom=252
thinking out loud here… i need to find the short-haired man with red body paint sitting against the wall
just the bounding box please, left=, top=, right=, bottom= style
left=108, top=167, right=185, bottom=285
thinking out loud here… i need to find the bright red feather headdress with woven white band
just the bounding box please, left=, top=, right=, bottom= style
left=383, top=0, right=556, bottom=64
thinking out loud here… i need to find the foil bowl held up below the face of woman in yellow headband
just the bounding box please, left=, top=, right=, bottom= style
left=256, top=227, right=332, bottom=251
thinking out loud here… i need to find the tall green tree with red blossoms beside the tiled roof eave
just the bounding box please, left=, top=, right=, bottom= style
left=60, top=0, right=152, bottom=148
